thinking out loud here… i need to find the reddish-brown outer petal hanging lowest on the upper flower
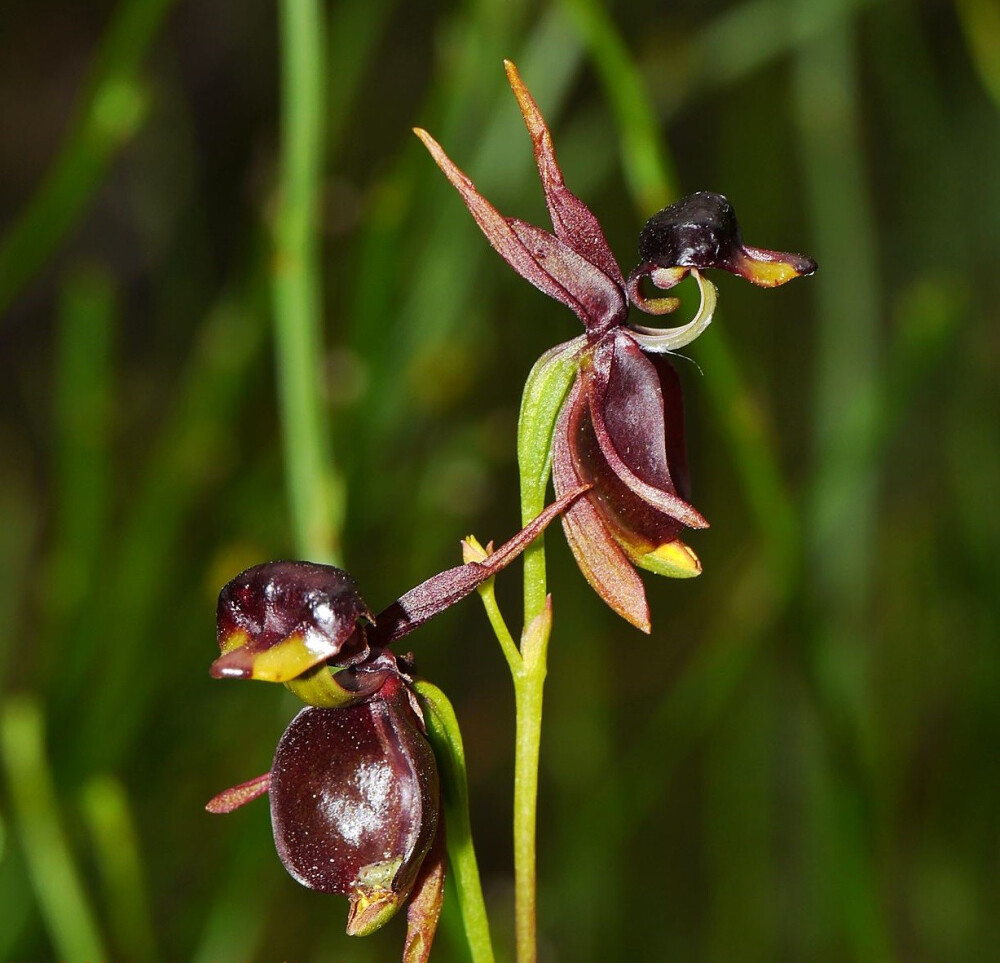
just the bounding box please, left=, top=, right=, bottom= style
left=552, top=380, right=650, bottom=633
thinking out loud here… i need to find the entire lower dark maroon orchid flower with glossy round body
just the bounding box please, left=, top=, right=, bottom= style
left=206, top=494, right=586, bottom=963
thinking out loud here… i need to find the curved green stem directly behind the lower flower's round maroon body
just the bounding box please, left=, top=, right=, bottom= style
left=415, top=680, right=494, bottom=963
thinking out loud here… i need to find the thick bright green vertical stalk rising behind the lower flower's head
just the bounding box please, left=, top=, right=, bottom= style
left=272, top=0, right=343, bottom=562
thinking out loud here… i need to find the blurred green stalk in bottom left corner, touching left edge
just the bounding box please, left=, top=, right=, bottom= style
left=0, top=697, right=109, bottom=960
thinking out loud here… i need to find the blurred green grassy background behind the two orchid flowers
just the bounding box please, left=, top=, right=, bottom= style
left=0, top=0, right=1000, bottom=963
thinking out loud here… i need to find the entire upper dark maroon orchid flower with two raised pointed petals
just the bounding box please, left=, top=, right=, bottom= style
left=416, top=62, right=816, bottom=632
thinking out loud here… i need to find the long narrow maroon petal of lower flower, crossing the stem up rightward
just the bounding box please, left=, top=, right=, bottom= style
left=371, top=485, right=587, bottom=645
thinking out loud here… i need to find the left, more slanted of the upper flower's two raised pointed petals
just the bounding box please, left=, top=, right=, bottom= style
left=414, top=128, right=628, bottom=331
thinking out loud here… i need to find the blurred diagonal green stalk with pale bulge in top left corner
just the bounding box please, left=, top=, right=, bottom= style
left=0, top=0, right=174, bottom=314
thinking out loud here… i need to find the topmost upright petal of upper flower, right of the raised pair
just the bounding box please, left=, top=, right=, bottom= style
left=504, top=60, right=625, bottom=287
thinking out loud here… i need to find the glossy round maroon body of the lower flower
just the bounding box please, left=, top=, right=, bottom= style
left=270, top=684, right=438, bottom=912
